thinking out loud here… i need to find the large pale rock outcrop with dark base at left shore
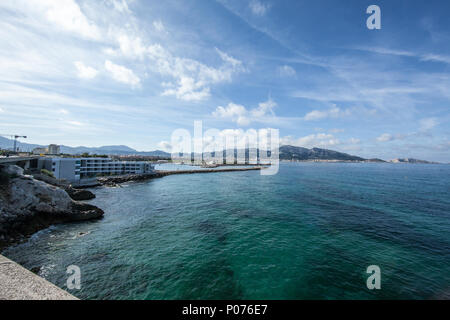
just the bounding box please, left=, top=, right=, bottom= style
left=0, top=166, right=104, bottom=249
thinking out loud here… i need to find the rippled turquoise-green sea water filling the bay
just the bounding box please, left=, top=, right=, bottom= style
left=4, top=163, right=450, bottom=299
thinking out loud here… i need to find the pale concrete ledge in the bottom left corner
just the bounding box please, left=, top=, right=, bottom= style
left=0, top=255, right=78, bottom=300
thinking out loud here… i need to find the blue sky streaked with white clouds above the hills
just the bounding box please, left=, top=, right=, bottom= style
left=0, top=0, right=450, bottom=162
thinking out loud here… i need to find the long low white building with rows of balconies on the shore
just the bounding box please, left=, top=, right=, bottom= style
left=39, top=158, right=154, bottom=182
